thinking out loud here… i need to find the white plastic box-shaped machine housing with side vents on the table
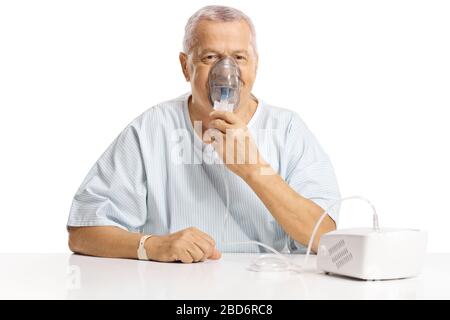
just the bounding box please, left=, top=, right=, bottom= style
left=317, top=228, right=427, bottom=280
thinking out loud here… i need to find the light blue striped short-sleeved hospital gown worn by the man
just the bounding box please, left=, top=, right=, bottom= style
left=67, top=93, right=340, bottom=252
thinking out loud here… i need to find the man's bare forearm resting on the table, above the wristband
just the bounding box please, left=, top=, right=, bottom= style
left=69, top=226, right=142, bottom=259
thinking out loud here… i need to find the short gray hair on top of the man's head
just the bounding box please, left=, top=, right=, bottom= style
left=183, top=6, right=258, bottom=54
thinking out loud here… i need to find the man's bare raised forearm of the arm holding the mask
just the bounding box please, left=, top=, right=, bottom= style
left=242, top=166, right=336, bottom=252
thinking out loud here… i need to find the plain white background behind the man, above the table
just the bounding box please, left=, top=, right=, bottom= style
left=0, top=0, right=450, bottom=252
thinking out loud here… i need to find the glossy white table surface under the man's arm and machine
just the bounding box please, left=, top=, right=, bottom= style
left=0, top=254, right=450, bottom=299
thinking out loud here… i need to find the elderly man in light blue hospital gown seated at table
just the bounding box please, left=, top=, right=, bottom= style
left=67, top=6, right=339, bottom=263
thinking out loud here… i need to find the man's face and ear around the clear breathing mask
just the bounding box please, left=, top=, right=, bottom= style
left=180, top=21, right=258, bottom=110
